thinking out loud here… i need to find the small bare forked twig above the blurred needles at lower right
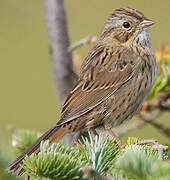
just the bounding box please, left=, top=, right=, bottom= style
left=137, top=139, right=169, bottom=160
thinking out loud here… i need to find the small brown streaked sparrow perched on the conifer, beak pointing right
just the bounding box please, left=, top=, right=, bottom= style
left=9, top=8, right=158, bottom=175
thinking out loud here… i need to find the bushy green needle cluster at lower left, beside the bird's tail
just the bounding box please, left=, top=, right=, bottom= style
left=24, top=141, right=83, bottom=180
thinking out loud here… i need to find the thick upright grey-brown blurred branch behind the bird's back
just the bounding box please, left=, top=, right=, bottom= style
left=45, top=0, right=76, bottom=105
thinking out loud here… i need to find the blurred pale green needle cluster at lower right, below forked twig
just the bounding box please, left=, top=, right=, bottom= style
left=116, top=145, right=158, bottom=180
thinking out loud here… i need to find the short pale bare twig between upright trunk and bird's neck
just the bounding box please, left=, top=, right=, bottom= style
left=69, top=36, right=97, bottom=52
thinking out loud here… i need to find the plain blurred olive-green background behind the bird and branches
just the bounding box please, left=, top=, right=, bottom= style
left=0, top=0, right=170, bottom=149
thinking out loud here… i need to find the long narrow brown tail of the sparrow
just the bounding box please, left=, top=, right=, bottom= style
left=8, top=124, right=69, bottom=176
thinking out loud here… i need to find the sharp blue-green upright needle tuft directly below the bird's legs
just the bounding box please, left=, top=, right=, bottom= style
left=80, top=133, right=120, bottom=174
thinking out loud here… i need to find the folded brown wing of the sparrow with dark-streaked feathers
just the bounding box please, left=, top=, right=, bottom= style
left=58, top=44, right=139, bottom=125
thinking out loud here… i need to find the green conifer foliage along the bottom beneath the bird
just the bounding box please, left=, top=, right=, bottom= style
left=8, top=131, right=170, bottom=180
